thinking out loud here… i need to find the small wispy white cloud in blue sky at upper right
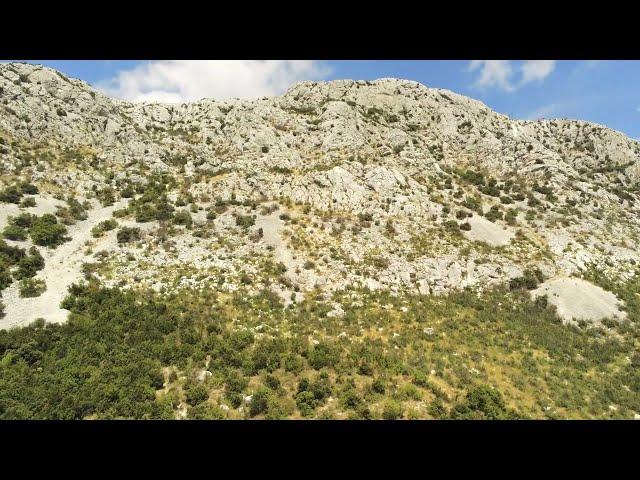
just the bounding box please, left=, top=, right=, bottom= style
left=469, top=60, right=556, bottom=92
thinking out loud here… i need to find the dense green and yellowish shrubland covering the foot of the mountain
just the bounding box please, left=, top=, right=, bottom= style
left=0, top=272, right=640, bottom=419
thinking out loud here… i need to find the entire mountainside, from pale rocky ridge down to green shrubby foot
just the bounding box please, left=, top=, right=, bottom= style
left=0, top=63, right=640, bottom=419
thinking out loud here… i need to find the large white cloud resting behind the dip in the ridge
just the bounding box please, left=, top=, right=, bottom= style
left=97, top=60, right=336, bottom=102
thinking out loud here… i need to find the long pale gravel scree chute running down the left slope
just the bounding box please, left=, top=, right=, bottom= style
left=0, top=202, right=125, bottom=329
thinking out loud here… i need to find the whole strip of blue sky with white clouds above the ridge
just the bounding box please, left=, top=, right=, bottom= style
left=13, top=60, right=640, bottom=139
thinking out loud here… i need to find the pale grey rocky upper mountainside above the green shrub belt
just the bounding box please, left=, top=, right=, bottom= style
left=0, top=63, right=640, bottom=324
